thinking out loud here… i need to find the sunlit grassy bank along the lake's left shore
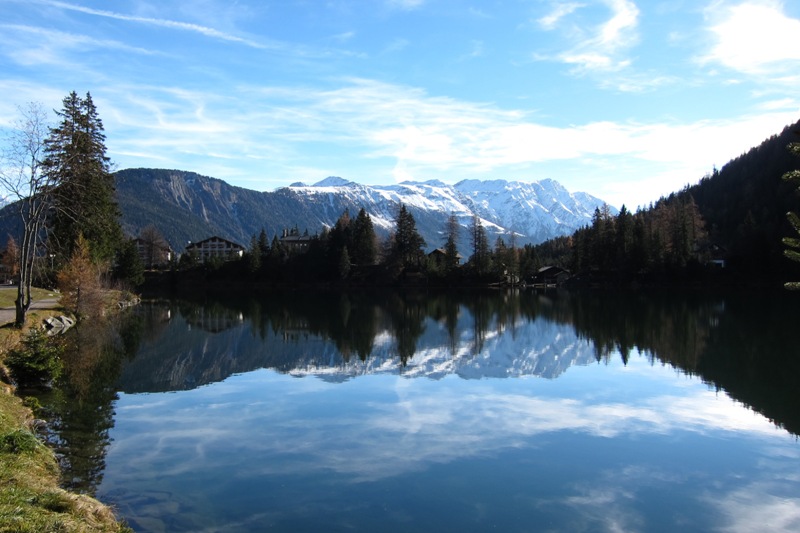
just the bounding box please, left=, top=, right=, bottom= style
left=0, top=290, right=130, bottom=533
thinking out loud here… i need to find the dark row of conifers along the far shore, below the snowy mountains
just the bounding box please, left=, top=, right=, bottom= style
left=159, top=205, right=556, bottom=286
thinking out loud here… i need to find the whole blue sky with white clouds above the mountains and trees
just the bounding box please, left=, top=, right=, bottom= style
left=0, top=0, right=800, bottom=208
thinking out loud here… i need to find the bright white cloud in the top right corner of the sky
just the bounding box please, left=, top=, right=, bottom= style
left=701, top=0, right=800, bottom=75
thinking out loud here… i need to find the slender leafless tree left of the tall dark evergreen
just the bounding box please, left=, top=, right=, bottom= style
left=0, top=102, right=55, bottom=327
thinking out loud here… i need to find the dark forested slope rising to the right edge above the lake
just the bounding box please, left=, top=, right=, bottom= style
left=535, top=119, right=800, bottom=286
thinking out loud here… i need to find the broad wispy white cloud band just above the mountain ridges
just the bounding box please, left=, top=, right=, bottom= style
left=95, top=79, right=798, bottom=207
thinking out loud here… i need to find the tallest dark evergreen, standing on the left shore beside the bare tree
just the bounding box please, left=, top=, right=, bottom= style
left=43, top=91, right=122, bottom=261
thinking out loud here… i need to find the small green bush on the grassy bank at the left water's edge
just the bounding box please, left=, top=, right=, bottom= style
left=5, top=329, right=64, bottom=388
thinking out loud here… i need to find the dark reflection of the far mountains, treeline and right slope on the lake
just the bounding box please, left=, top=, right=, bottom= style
left=119, top=290, right=800, bottom=434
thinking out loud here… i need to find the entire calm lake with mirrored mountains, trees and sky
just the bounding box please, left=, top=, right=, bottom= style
left=37, top=290, right=800, bottom=533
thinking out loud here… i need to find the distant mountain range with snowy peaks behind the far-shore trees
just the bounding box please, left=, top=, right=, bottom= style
left=115, top=168, right=616, bottom=255
